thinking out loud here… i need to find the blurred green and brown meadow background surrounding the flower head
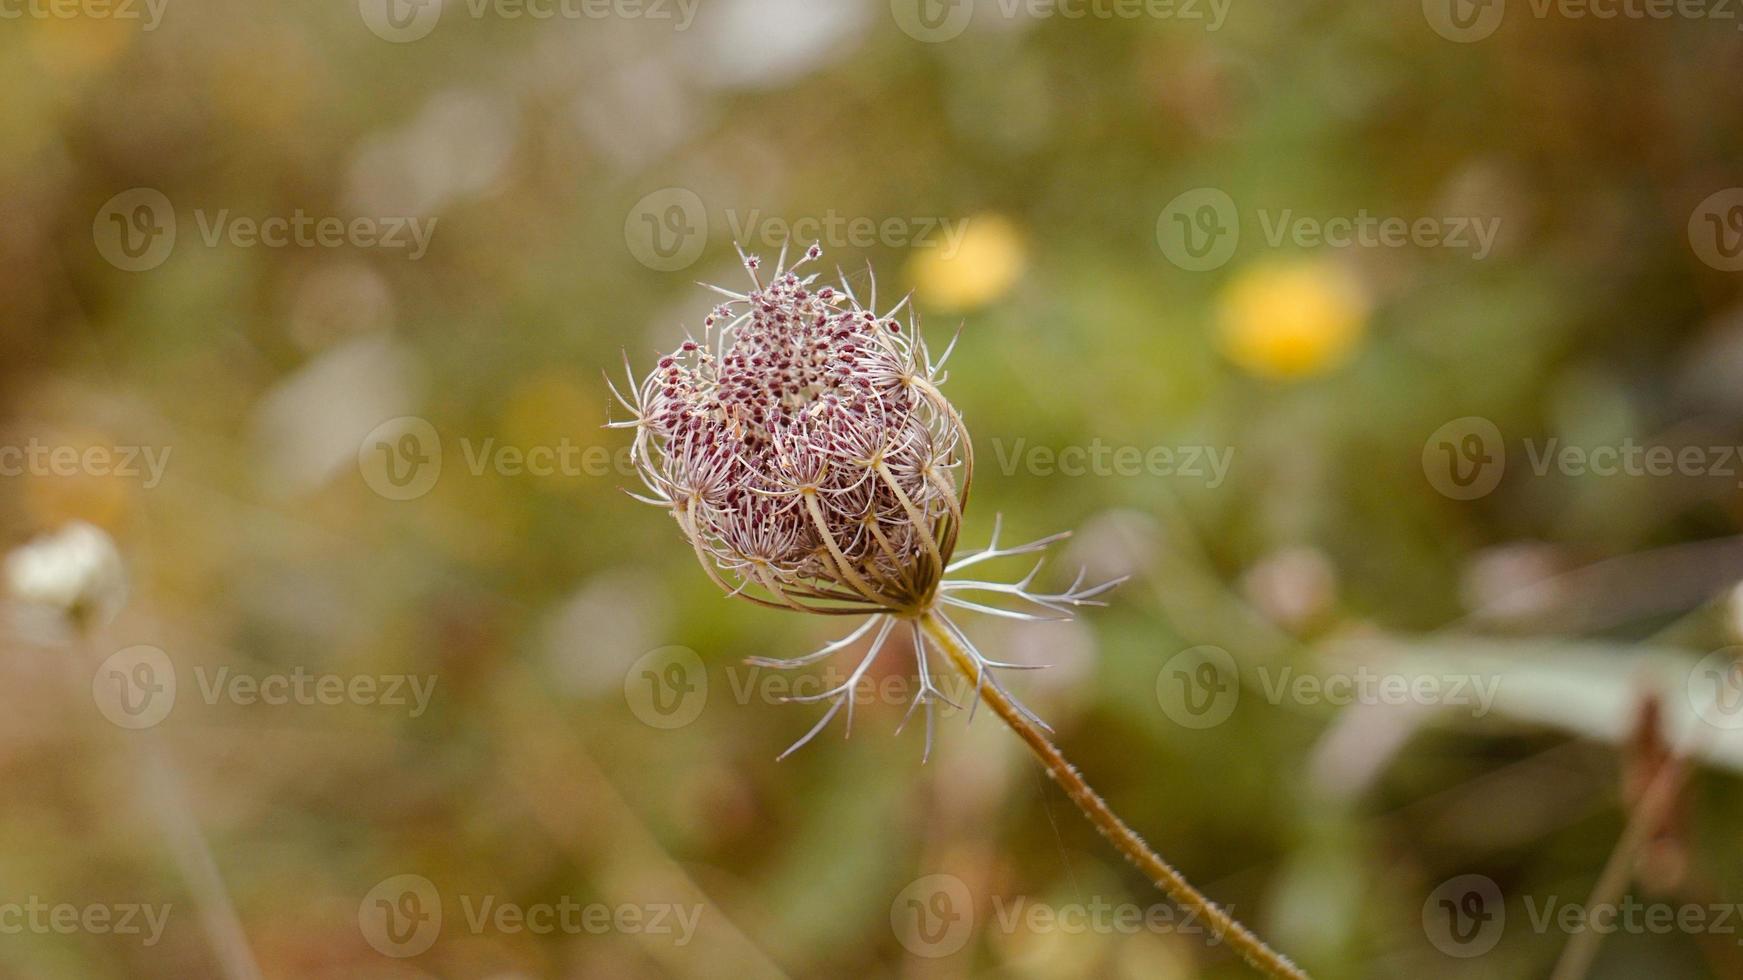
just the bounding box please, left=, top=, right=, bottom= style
left=0, top=0, right=1743, bottom=978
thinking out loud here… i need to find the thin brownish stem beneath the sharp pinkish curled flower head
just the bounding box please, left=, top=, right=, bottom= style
left=920, top=612, right=1307, bottom=980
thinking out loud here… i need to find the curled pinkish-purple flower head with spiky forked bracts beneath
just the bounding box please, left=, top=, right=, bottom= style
left=612, top=246, right=1117, bottom=752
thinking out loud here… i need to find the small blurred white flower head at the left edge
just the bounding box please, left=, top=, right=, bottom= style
left=5, top=521, right=127, bottom=624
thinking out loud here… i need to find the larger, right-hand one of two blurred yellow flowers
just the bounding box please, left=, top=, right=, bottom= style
left=1217, top=258, right=1368, bottom=378
